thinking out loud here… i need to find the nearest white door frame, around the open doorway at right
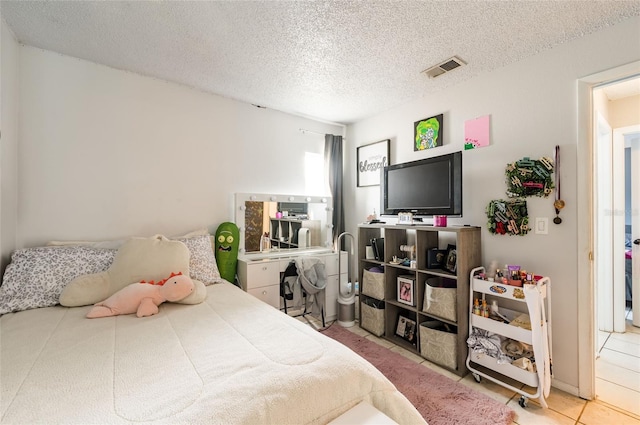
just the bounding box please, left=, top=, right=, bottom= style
left=576, top=61, right=640, bottom=400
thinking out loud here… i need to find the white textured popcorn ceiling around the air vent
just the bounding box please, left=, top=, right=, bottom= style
left=0, top=0, right=640, bottom=123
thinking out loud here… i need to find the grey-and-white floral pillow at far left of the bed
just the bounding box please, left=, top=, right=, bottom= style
left=0, top=245, right=117, bottom=314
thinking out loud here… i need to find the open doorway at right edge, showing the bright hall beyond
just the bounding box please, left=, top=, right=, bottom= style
left=592, top=77, right=640, bottom=414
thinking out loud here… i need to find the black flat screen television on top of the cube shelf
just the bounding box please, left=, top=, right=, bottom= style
left=380, top=152, right=462, bottom=217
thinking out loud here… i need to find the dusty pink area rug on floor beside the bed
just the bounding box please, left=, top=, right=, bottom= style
left=323, top=325, right=515, bottom=425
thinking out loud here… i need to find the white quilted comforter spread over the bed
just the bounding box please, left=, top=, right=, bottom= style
left=0, top=283, right=424, bottom=425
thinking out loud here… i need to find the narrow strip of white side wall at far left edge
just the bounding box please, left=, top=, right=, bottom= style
left=0, top=19, right=19, bottom=272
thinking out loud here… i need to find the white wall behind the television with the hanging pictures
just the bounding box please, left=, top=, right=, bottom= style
left=345, top=17, right=640, bottom=392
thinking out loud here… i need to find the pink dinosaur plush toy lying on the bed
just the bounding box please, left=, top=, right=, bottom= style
left=87, top=272, right=195, bottom=319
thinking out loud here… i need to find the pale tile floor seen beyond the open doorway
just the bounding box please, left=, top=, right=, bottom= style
left=596, top=308, right=640, bottom=416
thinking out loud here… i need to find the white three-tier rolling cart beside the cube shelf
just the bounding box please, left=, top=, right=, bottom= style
left=466, top=267, right=552, bottom=408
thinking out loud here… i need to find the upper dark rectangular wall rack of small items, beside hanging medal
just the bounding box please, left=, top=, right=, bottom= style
left=505, top=157, right=555, bottom=198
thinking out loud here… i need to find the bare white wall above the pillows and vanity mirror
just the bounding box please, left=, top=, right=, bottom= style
left=16, top=46, right=343, bottom=247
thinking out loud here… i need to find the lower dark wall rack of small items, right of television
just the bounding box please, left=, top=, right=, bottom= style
left=486, top=199, right=531, bottom=236
